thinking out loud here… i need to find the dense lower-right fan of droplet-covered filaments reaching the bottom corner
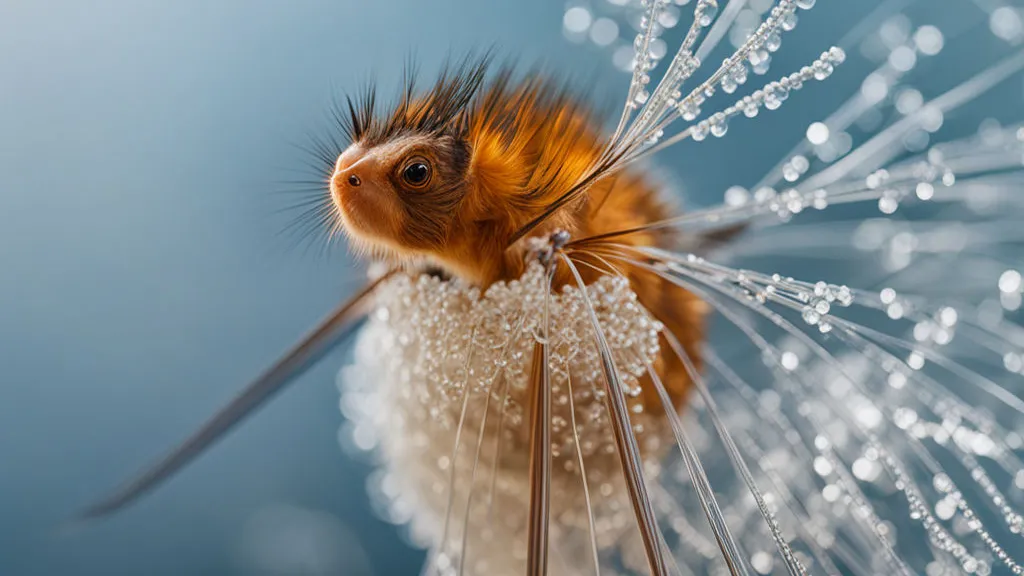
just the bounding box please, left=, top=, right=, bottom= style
left=618, top=242, right=1024, bottom=575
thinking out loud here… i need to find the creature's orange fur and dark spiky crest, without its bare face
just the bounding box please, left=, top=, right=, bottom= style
left=327, top=57, right=707, bottom=408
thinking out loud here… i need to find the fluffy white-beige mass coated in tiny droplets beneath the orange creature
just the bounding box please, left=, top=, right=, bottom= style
left=339, top=264, right=684, bottom=574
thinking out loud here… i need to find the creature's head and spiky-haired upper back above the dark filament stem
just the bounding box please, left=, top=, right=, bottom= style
left=319, top=54, right=649, bottom=285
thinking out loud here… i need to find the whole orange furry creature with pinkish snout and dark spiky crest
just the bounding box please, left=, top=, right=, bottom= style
left=331, top=63, right=706, bottom=409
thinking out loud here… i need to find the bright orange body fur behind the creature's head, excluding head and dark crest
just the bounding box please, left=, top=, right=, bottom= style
left=462, top=75, right=707, bottom=409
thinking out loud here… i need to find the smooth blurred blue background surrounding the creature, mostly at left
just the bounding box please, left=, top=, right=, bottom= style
left=0, top=0, right=1024, bottom=576
